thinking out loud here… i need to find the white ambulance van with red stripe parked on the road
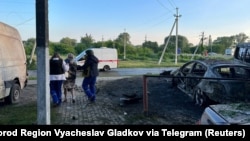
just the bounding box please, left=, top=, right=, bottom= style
left=75, top=47, right=118, bottom=71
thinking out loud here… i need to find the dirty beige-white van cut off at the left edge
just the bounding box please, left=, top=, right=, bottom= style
left=0, top=22, right=28, bottom=104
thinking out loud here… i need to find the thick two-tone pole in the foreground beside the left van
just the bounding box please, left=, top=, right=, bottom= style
left=36, top=0, right=50, bottom=125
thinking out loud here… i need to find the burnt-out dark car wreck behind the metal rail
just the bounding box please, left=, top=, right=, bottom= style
left=170, top=59, right=250, bottom=106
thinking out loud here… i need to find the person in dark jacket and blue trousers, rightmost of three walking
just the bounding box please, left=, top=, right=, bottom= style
left=81, top=50, right=99, bottom=102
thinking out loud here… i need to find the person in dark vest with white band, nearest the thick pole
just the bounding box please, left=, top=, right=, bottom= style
left=49, top=52, right=69, bottom=106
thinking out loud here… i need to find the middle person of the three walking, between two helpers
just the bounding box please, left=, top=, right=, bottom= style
left=63, top=53, right=77, bottom=103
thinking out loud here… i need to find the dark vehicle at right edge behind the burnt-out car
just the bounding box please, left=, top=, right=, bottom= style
left=234, top=43, right=250, bottom=66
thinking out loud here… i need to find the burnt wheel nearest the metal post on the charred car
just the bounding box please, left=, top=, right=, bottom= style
left=193, top=88, right=207, bottom=106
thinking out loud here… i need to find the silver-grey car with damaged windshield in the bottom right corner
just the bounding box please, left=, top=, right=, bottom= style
left=196, top=103, right=250, bottom=125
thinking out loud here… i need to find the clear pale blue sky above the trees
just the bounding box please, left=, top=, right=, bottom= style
left=0, top=0, right=250, bottom=45
